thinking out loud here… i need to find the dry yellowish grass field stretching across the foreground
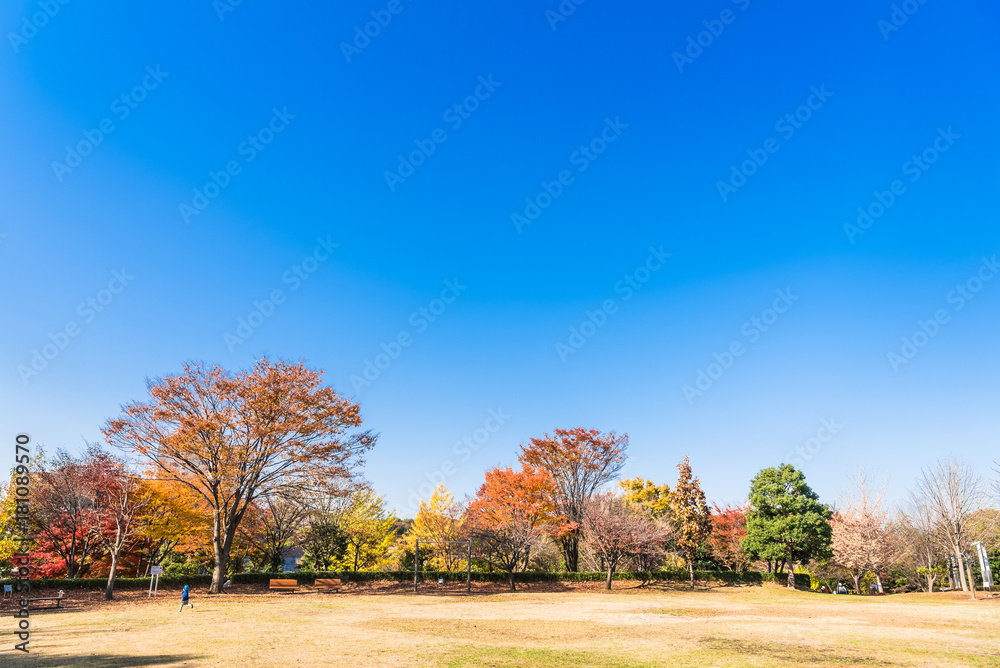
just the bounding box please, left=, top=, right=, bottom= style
left=0, top=583, right=1000, bottom=668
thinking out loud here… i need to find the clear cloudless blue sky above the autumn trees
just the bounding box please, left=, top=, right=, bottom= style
left=0, top=0, right=1000, bottom=515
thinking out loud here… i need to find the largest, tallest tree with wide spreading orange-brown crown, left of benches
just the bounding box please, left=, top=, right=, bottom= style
left=103, top=358, right=375, bottom=594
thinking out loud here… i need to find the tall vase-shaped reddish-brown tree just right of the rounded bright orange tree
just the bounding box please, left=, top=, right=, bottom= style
left=518, top=427, right=628, bottom=572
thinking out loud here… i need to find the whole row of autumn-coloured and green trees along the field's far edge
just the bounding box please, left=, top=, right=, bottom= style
left=0, top=358, right=1000, bottom=599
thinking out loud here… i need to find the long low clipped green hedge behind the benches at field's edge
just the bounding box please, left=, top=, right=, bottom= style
left=0, top=571, right=811, bottom=591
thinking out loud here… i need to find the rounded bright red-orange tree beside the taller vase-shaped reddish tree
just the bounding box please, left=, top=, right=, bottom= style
left=465, top=466, right=564, bottom=591
